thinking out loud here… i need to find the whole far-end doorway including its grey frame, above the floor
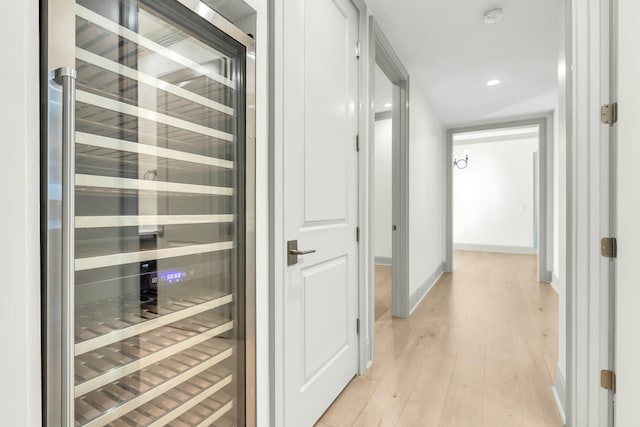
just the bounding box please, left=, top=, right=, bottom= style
left=445, top=116, right=553, bottom=283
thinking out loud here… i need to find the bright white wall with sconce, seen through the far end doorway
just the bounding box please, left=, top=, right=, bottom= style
left=453, top=139, right=538, bottom=248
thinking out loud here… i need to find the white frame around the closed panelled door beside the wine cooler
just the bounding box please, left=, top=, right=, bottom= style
left=268, top=0, right=369, bottom=426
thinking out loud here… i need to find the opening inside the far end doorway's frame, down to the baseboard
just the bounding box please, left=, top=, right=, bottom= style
left=453, top=126, right=540, bottom=256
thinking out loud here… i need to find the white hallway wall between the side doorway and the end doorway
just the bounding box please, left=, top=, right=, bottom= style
left=409, top=86, right=445, bottom=294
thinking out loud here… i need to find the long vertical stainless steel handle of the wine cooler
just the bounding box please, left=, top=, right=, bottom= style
left=54, top=67, right=76, bottom=426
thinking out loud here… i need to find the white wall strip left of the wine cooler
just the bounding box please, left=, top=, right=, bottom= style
left=0, top=0, right=41, bottom=427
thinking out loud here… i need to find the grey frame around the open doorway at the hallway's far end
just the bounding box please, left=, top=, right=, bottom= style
left=445, top=113, right=553, bottom=283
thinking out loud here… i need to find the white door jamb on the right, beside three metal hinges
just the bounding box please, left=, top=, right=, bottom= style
left=564, top=0, right=612, bottom=427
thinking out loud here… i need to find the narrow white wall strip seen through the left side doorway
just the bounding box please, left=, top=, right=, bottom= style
left=373, top=119, right=393, bottom=258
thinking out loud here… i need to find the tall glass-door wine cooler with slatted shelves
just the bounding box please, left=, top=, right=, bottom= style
left=41, top=0, right=255, bottom=427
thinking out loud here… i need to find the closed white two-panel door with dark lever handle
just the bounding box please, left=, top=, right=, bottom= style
left=283, top=0, right=358, bottom=427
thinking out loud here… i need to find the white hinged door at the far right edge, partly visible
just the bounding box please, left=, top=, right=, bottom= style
left=615, top=0, right=640, bottom=427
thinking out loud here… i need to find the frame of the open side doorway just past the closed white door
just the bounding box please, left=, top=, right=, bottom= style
left=359, top=16, right=411, bottom=373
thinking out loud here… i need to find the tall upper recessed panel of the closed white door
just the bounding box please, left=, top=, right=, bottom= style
left=304, top=1, right=354, bottom=222
